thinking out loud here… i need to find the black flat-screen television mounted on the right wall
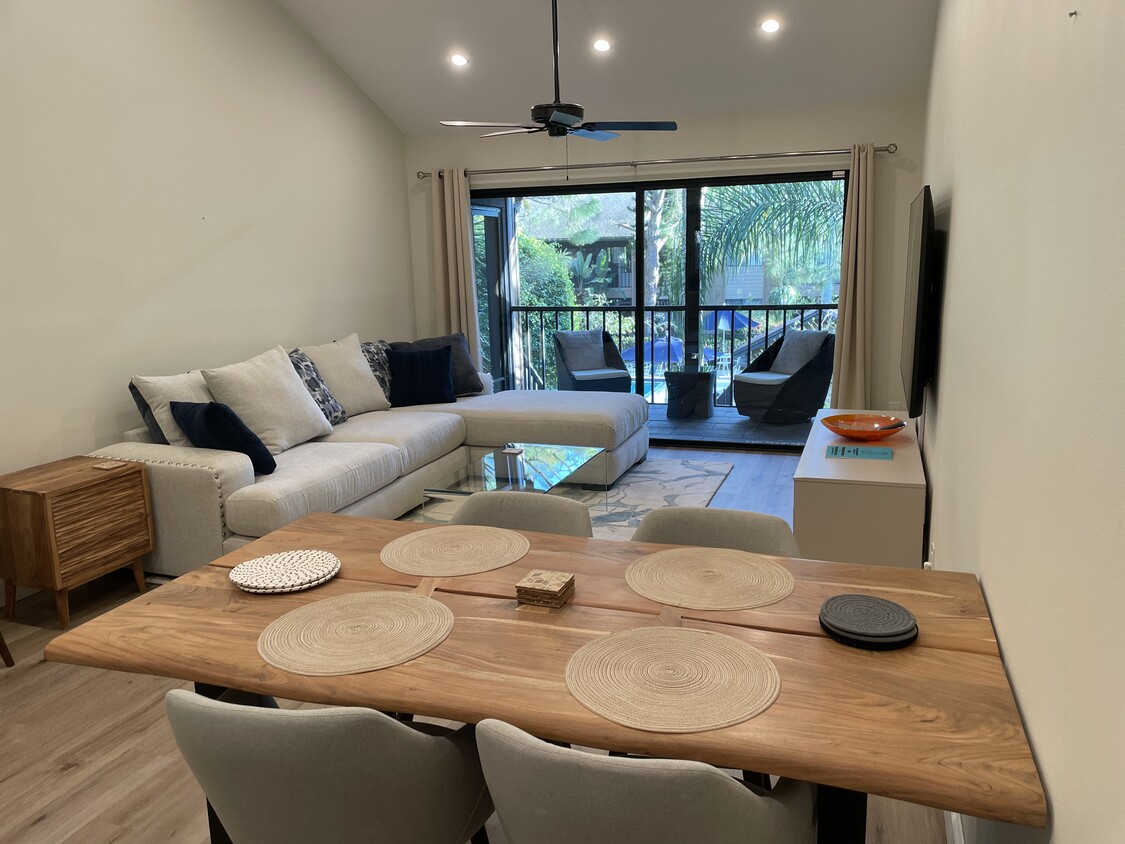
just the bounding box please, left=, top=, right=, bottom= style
left=899, top=185, right=942, bottom=419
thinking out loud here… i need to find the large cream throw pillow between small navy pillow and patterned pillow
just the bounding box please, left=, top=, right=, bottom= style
left=203, top=345, right=330, bottom=455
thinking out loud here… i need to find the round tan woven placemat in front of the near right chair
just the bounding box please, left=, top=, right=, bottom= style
left=566, top=627, right=781, bottom=733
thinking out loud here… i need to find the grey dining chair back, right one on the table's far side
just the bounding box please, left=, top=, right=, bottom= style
left=632, top=508, right=801, bottom=557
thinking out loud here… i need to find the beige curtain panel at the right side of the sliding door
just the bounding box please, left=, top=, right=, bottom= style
left=831, top=144, right=875, bottom=410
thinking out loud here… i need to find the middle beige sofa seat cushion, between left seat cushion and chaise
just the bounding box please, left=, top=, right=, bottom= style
left=318, top=414, right=465, bottom=475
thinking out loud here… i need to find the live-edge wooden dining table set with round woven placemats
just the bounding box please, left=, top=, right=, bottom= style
left=45, top=514, right=1047, bottom=842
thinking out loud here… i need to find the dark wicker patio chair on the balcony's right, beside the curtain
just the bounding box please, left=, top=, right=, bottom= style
left=734, top=330, right=836, bottom=425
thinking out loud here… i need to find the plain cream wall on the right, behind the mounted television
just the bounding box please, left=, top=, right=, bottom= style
left=924, top=0, right=1125, bottom=844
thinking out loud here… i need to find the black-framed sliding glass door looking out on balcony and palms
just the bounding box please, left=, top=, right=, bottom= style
left=474, top=173, right=845, bottom=414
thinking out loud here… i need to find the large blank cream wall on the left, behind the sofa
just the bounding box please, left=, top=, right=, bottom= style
left=0, top=0, right=413, bottom=472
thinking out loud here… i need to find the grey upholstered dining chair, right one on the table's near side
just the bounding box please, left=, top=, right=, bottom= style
left=477, top=719, right=816, bottom=844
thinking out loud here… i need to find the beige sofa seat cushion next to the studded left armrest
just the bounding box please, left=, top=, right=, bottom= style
left=226, top=438, right=402, bottom=537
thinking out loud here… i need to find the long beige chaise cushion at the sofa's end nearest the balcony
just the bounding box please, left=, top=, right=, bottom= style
left=392, top=389, right=648, bottom=450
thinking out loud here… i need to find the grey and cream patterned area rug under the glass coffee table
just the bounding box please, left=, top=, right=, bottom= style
left=402, top=459, right=734, bottom=539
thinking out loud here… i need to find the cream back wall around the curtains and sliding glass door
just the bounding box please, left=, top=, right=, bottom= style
left=406, top=98, right=924, bottom=407
